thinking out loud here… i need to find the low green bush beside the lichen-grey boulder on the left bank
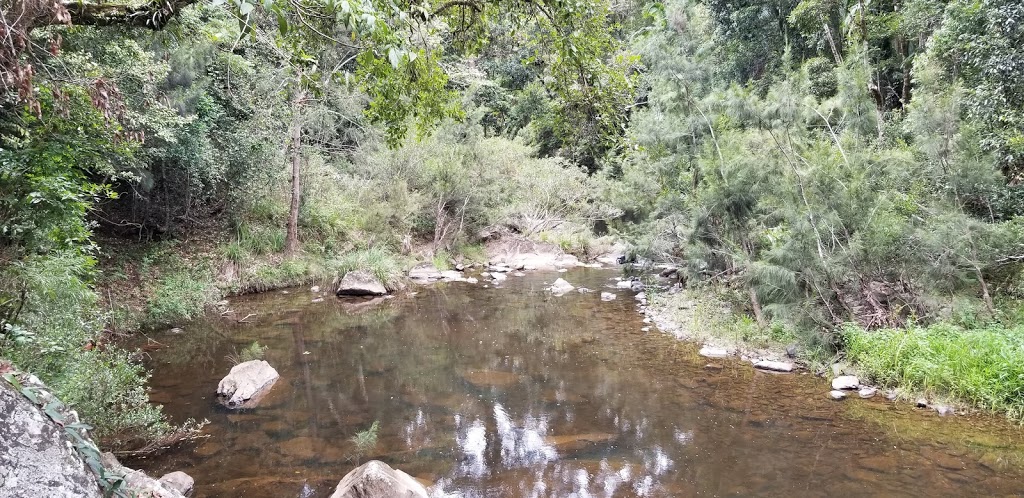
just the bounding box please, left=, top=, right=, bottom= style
left=0, top=252, right=174, bottom=449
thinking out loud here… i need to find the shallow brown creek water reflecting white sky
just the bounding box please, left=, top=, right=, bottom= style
left=128, top=269, right=1024, bottom=497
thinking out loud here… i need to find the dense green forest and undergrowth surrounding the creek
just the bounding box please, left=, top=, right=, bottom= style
left=0, top=0, right=1024, bottom=448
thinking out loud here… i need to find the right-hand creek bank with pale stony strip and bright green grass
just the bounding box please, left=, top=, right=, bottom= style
left=641, top=274, right=1024, bottom=422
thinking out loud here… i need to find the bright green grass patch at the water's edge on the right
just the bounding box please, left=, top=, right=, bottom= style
left=843, top=323, right=1024, bottom=421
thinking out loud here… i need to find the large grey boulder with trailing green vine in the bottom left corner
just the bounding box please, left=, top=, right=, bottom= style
left=0, top=372, right=103, bottom=498
